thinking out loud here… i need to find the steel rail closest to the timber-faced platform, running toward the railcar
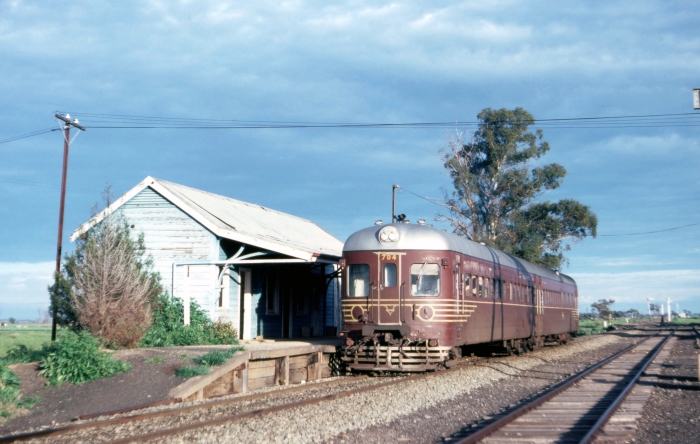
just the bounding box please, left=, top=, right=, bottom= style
left=0, top=375, right=367, bottom=443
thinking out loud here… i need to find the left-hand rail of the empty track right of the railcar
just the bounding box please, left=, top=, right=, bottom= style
left=457, top=331, right=670, bottom=444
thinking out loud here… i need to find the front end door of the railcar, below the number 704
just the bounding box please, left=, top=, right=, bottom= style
left=374, top=251, right=406, bottom=325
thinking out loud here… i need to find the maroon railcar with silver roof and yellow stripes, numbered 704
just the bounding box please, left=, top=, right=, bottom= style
left=341, top=223, right=578, bottom=372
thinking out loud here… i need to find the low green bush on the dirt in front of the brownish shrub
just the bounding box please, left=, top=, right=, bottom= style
left=39, top=331, right=131, bottom=386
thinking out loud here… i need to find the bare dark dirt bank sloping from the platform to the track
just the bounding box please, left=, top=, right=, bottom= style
left=0, top=346, right=235, bottom=435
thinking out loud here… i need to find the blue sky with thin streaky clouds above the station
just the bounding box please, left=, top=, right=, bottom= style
left=0, top=1, right=700, bottom=318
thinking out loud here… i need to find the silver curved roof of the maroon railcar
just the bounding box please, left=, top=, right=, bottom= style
left=343, top=223, right=576, bottom=285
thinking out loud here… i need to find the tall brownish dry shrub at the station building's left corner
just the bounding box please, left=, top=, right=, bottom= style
left=70, top=189, right=161, bottom=347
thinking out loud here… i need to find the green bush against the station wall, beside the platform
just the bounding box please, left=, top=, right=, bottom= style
left=140, top=294, right=238, bottom=347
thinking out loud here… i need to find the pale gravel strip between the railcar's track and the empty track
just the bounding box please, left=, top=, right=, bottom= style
left=154, top=335, right=633, bottom=443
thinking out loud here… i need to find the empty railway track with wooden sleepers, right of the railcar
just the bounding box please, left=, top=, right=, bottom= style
left=453, top=330, right=676, bottom=444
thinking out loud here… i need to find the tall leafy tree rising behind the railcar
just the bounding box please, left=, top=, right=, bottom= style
left=442, top=108, right=598, bottom=269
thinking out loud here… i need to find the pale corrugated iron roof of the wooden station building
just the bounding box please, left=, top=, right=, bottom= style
left=71, top=177, right=343, bottom=261
